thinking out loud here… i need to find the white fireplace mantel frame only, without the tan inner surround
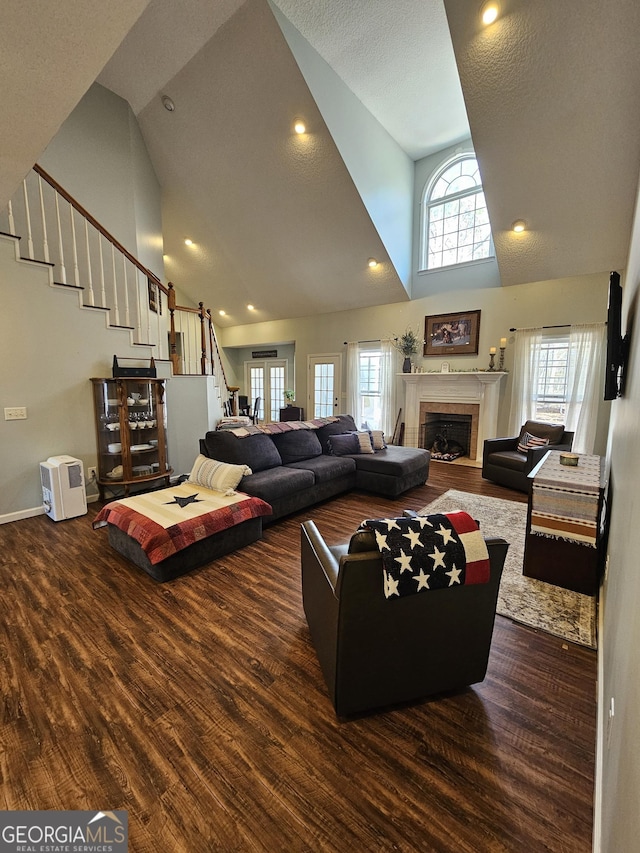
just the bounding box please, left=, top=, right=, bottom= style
left=399, top=370, right=506, bottom=458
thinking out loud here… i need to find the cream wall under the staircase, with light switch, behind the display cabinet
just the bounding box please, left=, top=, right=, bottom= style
left=0, top=236, right=150, bottom=520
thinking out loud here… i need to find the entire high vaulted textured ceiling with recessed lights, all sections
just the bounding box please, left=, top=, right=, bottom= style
left=0, top=0, right=640, bottom=324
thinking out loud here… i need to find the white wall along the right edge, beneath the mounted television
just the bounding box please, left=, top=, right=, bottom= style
left=594, top=165, right=640, bottom=853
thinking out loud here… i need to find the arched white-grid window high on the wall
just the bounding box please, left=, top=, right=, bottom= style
left=421, top=154, right=494, bottom=270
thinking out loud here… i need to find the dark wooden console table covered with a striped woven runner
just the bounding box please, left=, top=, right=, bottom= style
left=523, top=450, right=605, bottom=595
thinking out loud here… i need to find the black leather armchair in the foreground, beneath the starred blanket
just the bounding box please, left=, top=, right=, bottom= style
left=301, top=521, right=509, bottom=717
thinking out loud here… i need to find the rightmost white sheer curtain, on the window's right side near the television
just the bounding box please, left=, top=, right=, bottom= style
left=567, top=323, right=606, bottom=453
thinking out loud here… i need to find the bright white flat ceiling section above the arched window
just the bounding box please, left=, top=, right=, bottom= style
left=275, top=0, right=469, bottom=160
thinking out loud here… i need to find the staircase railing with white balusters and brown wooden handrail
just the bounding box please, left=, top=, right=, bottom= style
left=0, top=165, right=234, bottom=409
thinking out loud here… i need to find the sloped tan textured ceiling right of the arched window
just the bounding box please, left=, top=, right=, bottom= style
left=445, top=0, right=640, bottom=285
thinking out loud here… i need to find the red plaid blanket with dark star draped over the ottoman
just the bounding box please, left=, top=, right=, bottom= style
left=93, top=483, right=271, bottom=565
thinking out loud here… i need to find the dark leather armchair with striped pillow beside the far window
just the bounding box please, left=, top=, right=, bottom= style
left=482, top=421, right=573, bottom=492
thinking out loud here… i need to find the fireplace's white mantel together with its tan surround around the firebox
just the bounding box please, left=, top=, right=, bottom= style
left=399, top=370, right=506, bottom=461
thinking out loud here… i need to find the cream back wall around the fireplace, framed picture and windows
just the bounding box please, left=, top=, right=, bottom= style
left=219, top=272, right=610, bottom=453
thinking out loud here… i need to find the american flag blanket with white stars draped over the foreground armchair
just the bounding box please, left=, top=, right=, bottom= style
left=363, top=512, right=490, bottom=598
